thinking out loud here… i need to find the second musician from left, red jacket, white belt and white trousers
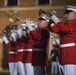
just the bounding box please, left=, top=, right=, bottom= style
left=15, top=27, right=25, bottom=75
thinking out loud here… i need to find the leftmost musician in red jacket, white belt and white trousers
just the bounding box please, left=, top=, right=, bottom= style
left=3, top=33, right=17, bottom=75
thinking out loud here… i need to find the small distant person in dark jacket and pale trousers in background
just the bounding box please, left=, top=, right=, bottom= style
left=50, top=40, right=59, bottom=74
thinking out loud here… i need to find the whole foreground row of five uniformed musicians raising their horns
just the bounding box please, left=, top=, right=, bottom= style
left=2, top=6, right=76, bottom=75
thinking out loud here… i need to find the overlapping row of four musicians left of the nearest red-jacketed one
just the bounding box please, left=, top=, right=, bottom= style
left=3, top=9, right=49, bottom=75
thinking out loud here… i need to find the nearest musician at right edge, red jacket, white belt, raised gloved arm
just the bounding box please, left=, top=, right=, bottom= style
left=50, top=6, right=76, bottom=75
